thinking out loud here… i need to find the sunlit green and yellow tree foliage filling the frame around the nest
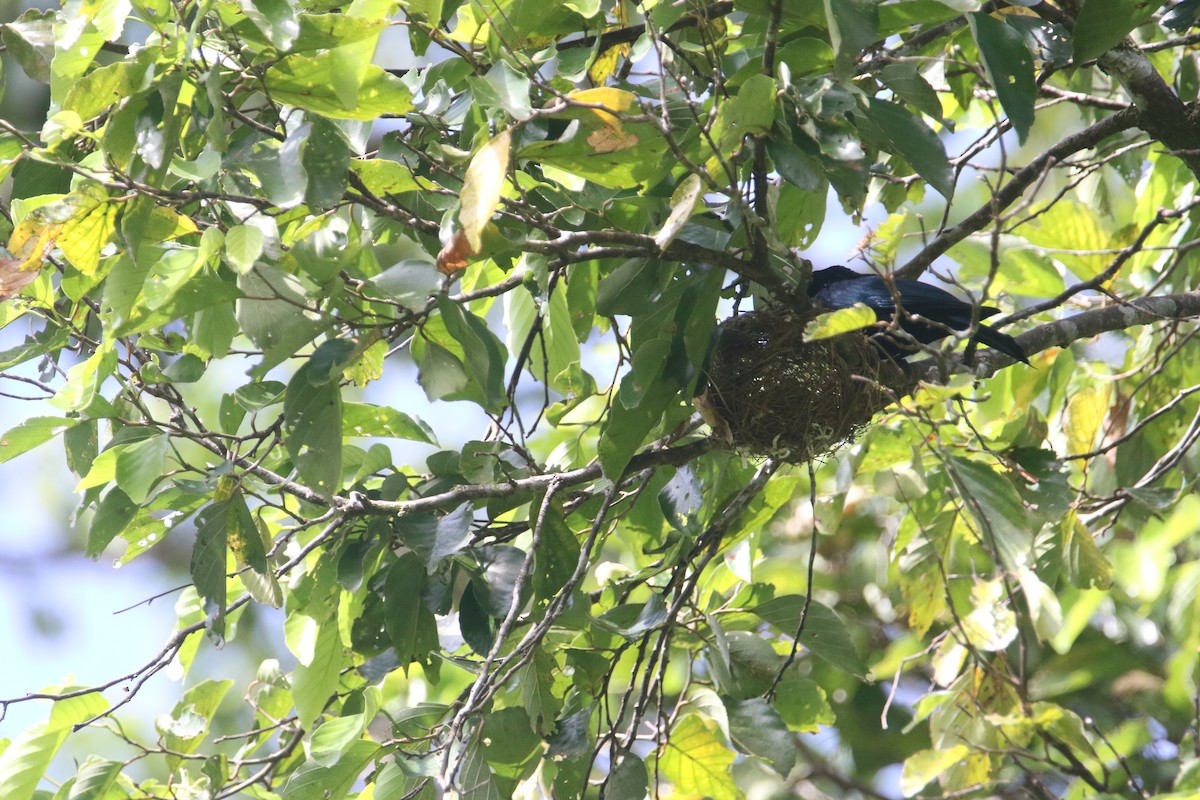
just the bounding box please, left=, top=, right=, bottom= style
left=0, top=0, right=1200, bottom=800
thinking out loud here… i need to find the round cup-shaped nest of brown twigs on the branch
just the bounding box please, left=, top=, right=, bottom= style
left=696, top=308, right=906, bottom=463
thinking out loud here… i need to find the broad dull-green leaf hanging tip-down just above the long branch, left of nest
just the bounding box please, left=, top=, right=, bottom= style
left=283, top=362, right=342, bottom=498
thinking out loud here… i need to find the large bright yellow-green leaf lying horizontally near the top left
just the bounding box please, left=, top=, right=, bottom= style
left=264, top=49, right=413, bottom=121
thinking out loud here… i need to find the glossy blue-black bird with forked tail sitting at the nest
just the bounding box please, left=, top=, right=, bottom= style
left=809, top=266, right=1030, bottom=363
